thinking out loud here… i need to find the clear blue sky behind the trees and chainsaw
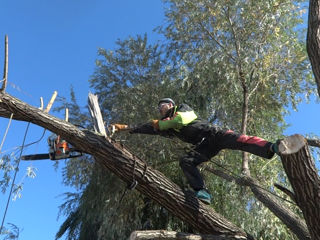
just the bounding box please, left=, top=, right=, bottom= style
left=0, top=0, right=320, bottom=240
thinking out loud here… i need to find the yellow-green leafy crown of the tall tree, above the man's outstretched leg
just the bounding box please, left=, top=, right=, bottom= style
left=159, top=0, right=314, bottom=129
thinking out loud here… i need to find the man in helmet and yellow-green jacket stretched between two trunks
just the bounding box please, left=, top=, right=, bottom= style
left=112, top=98, right=278, bottom=204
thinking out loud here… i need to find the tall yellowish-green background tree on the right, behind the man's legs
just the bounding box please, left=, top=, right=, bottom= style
left=160, top=1, right=314, bottom=239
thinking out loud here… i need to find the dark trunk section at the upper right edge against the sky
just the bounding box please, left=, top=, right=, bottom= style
left=307, top=0, right=320, bottom=96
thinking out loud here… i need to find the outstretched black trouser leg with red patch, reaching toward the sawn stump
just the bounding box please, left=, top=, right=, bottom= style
left=215, top=130, right=274, bottom=159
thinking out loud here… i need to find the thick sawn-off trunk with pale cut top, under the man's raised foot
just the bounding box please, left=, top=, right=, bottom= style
left=279, top=134, right=320, bottom=240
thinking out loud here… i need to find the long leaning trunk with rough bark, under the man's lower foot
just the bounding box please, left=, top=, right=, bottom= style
left=0, top=92, right=250, bottom=239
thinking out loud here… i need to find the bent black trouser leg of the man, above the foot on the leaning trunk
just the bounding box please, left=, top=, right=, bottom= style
left=180, top=151, right=209, bottom=191
